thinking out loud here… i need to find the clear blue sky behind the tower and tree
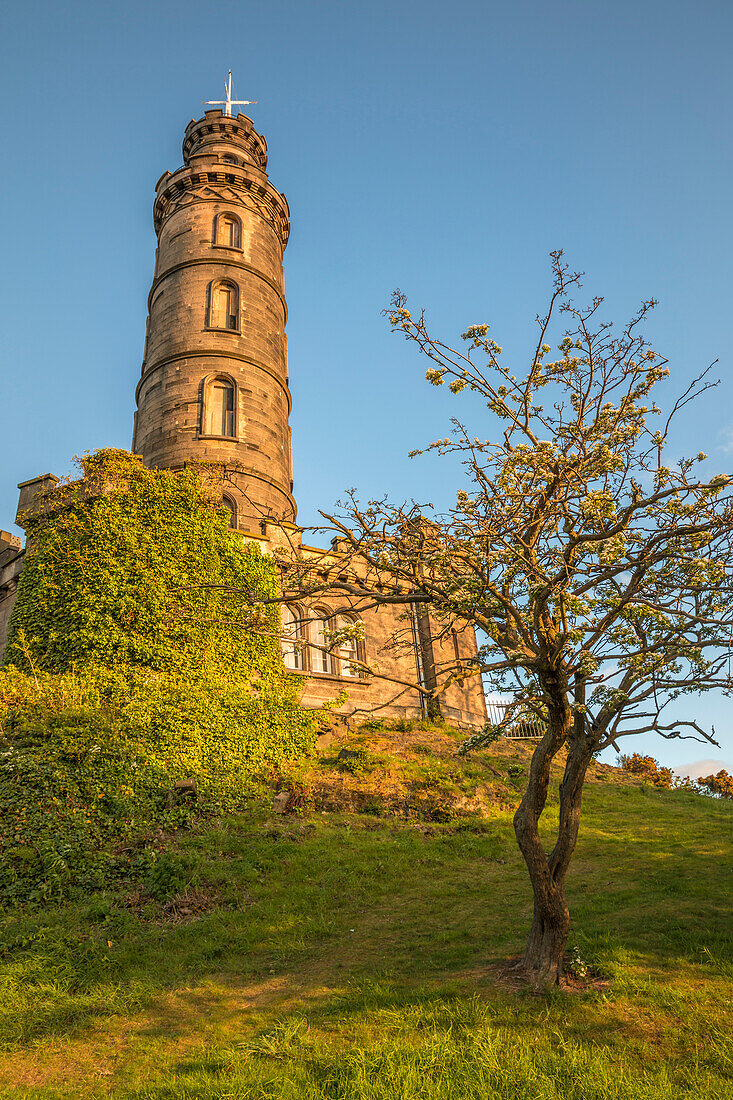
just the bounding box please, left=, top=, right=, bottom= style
left=0, top=0, right=733, bottom=767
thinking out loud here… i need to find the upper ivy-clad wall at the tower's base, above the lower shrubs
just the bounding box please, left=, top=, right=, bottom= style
left=3, top=450, right=280, bottom=672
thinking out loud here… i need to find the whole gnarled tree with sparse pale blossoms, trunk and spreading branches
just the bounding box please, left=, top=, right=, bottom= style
left=277, top=252, right=733, bottom=987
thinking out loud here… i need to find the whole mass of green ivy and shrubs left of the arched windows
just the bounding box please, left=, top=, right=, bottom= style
left=0, top=452, right=317, bottom=901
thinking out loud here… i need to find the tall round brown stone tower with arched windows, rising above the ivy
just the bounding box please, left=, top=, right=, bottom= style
left=132, top=110, right=296, bottom=534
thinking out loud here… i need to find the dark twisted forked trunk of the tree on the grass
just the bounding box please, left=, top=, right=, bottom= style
left=514, top=706, right=592, bottom=989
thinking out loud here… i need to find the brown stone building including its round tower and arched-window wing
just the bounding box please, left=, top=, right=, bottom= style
left=0, top=105, right=486, bottom=727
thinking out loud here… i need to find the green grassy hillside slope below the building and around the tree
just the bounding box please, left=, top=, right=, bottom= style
left=0, top=729, right=733, bottom=1100
